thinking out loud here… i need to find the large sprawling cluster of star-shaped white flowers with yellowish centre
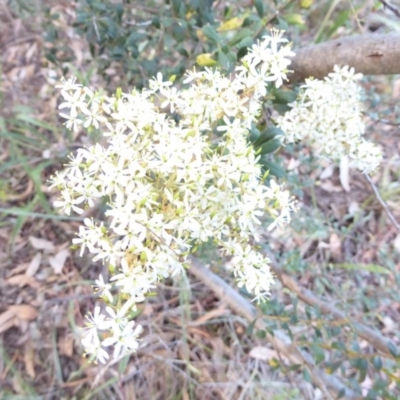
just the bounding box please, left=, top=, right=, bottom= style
left=53, top=31, right=295, bottom=362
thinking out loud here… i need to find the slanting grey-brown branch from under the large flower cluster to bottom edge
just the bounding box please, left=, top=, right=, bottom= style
left=189, top=258, right=362, bottom=400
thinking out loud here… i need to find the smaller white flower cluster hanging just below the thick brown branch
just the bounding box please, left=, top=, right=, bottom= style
left=277, top=65, right=382, bottom=173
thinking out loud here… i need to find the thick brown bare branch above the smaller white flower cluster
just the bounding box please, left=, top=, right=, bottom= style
left=288, top=33, right=400, bottom=82
